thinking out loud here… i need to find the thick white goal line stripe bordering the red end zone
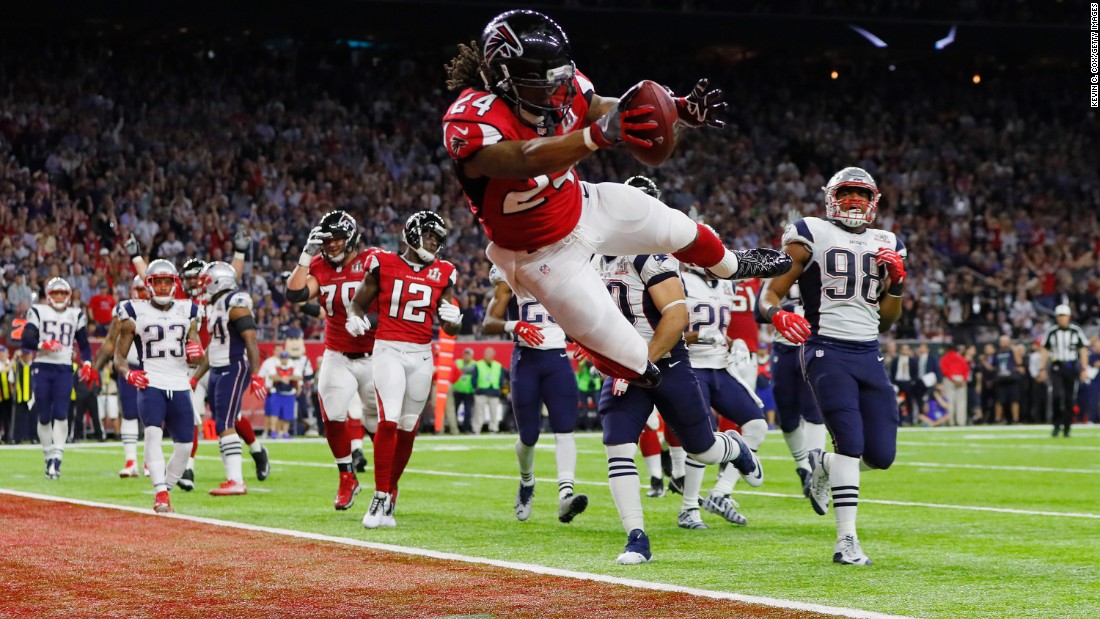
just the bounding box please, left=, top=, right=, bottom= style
left=0, top=488, right=908, bottom=619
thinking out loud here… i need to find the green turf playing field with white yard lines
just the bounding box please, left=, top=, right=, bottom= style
left=0, top=427, right=1100, bottom=618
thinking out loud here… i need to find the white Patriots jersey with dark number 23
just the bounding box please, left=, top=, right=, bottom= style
left=121, top=299, right=199, bottom=391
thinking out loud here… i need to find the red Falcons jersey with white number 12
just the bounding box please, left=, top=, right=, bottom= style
left=367, top=252, right=457, bottom=344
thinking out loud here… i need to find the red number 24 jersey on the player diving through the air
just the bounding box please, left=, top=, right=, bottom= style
left=443, top=73, right=593, bottom=251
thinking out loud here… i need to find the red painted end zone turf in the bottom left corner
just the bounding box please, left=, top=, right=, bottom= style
left=0, top=495, right=823, bottom=619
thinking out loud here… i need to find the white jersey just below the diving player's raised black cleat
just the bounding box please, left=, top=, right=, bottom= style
left=682, top=270, right=734, bottom=369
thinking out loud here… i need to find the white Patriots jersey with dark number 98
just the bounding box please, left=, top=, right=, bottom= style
left=783, top=217, right=906, bottom=342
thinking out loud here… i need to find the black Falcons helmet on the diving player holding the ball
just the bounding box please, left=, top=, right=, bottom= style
left=481, top=10, right=576, bottom=132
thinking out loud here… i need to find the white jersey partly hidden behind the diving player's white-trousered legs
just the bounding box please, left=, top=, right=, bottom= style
left=592, top=254, right=683, bottom=354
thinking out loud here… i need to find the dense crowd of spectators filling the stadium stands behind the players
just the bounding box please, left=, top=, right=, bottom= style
left=0, top=43, right=1100, bottom=354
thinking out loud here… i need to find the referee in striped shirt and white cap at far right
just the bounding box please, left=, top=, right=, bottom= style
left=1043, top=305, right=1089, bottom=438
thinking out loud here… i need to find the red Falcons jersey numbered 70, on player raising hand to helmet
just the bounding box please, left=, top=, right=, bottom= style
left=309, top=247, right=381, bottom=353
